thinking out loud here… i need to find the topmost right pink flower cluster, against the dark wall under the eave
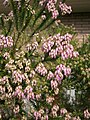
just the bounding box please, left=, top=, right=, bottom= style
left=59, top=2, right=72, bottom=15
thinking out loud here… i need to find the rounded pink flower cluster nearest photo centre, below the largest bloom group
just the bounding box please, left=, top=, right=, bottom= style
left=35, top=63, right=47, bottom=76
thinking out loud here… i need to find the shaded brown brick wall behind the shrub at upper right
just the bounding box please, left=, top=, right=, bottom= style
left=61, top=12, right=90, bottom=34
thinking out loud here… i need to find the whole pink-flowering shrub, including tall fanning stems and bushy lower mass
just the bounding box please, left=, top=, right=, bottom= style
left=0, top=0, right=90, bottom=120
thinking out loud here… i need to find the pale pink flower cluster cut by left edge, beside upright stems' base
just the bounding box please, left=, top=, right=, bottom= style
left=0, top=35, right=13, bottom=49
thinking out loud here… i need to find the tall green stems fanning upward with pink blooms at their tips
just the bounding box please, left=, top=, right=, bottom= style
left=0, top=0, right=72, bottom=49
